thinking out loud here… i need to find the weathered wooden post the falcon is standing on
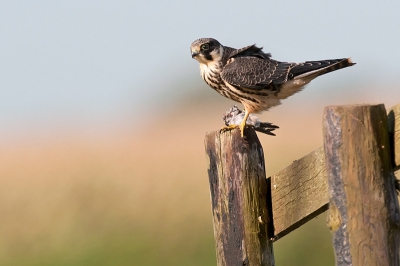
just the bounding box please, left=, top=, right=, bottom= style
left=205, top=129, right=275, bottom=266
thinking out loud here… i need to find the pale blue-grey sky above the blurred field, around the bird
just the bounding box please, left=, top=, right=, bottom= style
left=0, top=0, right=400, bottom=139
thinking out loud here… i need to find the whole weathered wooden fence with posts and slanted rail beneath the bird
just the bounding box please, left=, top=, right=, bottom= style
left=205, top=104, right=400, bottom=266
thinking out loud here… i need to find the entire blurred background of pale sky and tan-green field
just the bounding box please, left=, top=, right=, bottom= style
left=0, top=1, right=400, bottom=266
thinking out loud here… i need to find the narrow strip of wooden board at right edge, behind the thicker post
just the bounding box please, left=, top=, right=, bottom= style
left=388, top=104, right=400, bottom=169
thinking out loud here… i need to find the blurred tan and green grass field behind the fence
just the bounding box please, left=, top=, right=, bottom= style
left=0, top=100, right=334, bottom=266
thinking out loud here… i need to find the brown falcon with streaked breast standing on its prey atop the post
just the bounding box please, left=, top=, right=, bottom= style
left=190, top=38, right=355, bottom=137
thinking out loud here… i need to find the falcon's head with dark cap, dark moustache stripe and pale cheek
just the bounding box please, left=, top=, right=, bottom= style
left=190, top=38, right=224, bottom=65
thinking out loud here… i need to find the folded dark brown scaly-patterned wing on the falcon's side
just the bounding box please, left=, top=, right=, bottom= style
left=221, top=56, right=295, bottom=90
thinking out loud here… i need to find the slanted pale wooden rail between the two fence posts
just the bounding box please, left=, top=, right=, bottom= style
left=270, top=147, right=329, bottom=240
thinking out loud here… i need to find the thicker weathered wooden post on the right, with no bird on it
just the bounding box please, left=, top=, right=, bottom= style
left=323, top=104, right=400, bottom=266
